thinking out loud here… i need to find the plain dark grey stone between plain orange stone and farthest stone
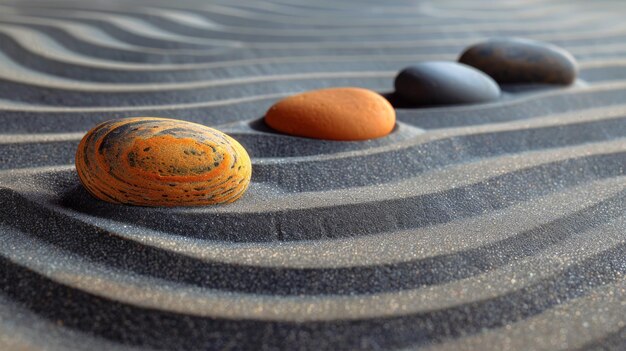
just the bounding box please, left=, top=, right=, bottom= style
left=394, top=61, right=500, bottom=106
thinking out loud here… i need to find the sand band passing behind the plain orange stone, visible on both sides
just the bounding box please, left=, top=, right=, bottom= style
left=6, top=82, right=625, bottom=133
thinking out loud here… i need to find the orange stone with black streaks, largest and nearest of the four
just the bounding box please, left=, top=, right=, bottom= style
left=76, top=117, right=252, bottom=206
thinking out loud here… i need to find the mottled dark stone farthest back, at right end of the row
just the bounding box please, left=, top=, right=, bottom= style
left=459, top=38, right=578, bottom=85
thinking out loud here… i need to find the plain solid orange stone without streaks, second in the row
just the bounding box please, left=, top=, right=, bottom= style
left=265, top=88, right=396, bottom=140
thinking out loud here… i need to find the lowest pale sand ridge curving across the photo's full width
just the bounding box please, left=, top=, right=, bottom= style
left=5, top=213, right=625, bottom=321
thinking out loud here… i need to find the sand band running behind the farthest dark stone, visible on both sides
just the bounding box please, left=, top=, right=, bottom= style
left=0, top=34, right=624, bottom=83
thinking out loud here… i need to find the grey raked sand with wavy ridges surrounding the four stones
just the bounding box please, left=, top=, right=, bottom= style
left=0, top=0, right=626, bottom=351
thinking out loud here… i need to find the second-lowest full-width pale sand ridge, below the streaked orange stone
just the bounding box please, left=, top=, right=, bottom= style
left=1, top=170, right=623, bottom=268
